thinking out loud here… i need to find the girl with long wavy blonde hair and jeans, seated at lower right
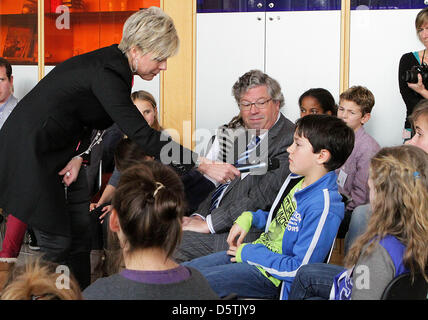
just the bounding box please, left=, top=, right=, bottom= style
left=290, top=145, right=428, bottom=300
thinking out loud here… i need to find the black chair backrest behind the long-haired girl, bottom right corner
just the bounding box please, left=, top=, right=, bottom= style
left=381, top=273, right=428, bottom=300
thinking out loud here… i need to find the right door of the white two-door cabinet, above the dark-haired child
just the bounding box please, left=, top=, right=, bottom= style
left=265, top=10, right=340, bottom=121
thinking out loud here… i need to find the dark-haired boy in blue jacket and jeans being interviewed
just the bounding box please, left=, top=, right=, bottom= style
left=186, top=115, right=354, bottom=299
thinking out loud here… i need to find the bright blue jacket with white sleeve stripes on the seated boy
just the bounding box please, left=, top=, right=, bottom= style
left=237, top=171, right=345, bottom=300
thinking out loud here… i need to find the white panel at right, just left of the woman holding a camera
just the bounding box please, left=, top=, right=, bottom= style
left=349, top=9, right=423, bottom=146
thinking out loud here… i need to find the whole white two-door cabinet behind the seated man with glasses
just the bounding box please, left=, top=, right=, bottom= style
left=196, top=10, right=340, bottom=129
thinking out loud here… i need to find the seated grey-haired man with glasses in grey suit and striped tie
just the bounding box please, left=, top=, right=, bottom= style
left=174, top=70, right=294, bottom=261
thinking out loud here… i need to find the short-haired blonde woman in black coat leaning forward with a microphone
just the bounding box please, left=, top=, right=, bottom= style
left=0, top=7, right=240, bottom=287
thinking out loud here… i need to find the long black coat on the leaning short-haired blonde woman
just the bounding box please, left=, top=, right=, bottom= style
left=0, top=45, right=193, bottom=235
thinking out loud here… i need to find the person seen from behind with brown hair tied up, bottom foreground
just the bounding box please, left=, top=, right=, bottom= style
left=83, top=161, right=218, bottom=300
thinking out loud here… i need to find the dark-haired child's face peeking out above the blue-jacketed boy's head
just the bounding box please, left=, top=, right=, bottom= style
left=299, top=88, right=337, bottom=117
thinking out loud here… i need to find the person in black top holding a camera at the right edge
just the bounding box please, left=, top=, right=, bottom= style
left=398, top=7, right=428, bottom=140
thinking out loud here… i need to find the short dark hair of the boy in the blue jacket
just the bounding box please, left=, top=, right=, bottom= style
left=296, top=114, right=355, bottom=171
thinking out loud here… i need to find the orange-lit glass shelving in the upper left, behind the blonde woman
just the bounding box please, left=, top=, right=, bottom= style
left=0, top=0, right=160, bottom=65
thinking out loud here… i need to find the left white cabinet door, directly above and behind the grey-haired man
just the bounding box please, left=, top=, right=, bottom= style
left=196, top=12, right=266, bottom=130
